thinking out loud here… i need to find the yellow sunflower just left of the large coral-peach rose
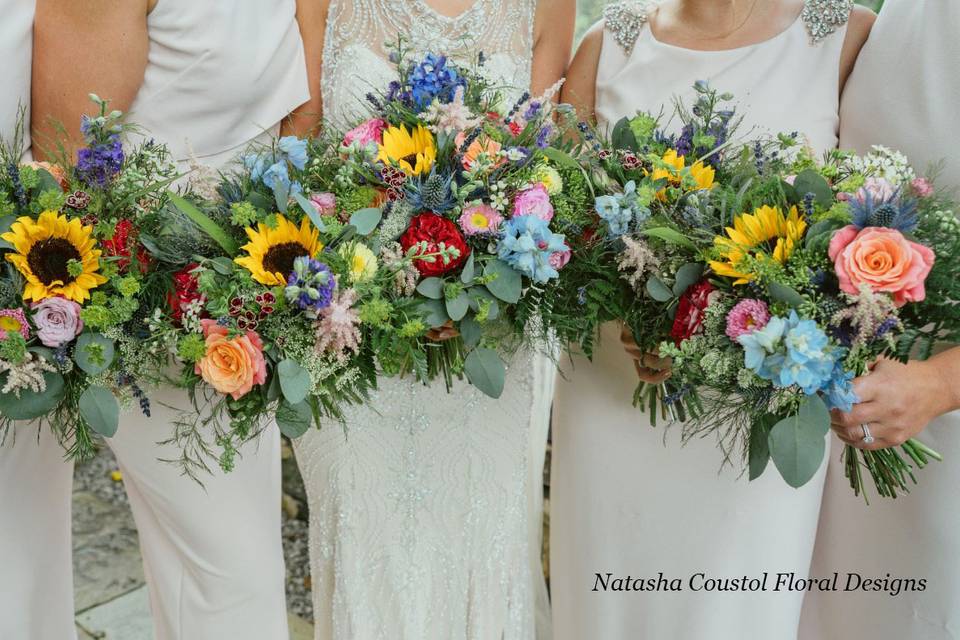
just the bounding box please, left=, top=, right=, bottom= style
left=710, top=206, right=807, bottom=285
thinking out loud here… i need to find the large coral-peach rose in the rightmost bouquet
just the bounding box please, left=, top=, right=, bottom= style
left=829, top=225, right=936, bottom=307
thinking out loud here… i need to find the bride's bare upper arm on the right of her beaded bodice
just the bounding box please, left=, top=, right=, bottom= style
left=530, top=0, right=577, bottom=96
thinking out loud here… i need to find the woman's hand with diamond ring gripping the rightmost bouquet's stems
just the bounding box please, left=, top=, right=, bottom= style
left=831, top=352, right=960, bottom=451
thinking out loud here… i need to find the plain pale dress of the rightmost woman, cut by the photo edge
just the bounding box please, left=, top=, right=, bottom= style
left=801, top=0, right=960, bottom=640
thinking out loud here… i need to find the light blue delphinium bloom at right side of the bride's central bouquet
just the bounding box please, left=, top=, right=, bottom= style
left=498, top=216, right=570, bottom=283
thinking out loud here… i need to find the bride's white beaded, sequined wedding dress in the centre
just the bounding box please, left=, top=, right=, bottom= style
left=295, top=0, right=554, bottom=640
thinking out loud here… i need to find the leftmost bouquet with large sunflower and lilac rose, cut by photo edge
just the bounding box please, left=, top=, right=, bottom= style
left=0, top=96, right=174, bottom=459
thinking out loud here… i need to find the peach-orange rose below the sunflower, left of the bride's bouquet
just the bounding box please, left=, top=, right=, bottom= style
left=195, top=319, right=267, bottom=400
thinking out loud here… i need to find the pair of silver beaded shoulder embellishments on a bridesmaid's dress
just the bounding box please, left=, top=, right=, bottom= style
left=603, top=0, right=853, bottom=54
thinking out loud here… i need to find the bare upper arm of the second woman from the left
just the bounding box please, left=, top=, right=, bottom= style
left=31, top=0, right=156, bottom=159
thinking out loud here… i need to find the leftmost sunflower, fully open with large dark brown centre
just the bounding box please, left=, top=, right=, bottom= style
left=0, top=211, right=107, bottom=303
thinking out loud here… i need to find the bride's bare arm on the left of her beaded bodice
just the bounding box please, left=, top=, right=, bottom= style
left=280, top=0, right=330, bottom=138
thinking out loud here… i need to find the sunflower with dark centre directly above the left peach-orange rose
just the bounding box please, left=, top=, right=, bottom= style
left=234, top=213, right=323, bottom=287
